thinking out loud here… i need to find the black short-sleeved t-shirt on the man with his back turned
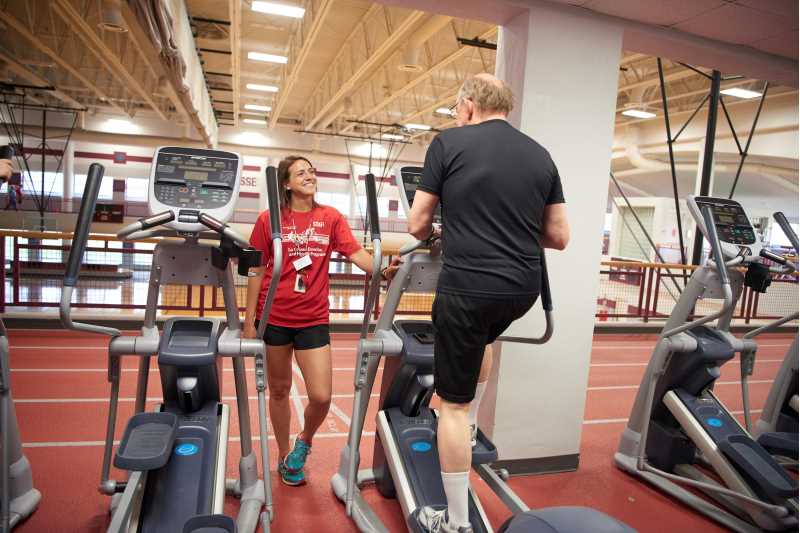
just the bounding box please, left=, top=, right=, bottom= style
left=419, top=119, right=564, bottom=298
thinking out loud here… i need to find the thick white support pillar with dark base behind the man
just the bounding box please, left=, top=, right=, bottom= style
left=479, top=6, right=622, bottom=473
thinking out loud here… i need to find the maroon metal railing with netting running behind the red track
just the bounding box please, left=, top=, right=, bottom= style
left=0, top=231, right=798, bottom=323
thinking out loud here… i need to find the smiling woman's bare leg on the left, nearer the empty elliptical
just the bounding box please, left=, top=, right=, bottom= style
left=267, top=344, right=292, bottom=461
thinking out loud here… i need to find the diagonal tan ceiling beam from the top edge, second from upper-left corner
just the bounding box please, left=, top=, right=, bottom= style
left=50, top=0, right=168, bottom=120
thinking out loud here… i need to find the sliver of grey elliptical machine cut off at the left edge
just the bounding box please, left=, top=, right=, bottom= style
left=0, top=318, right=42, bottom=533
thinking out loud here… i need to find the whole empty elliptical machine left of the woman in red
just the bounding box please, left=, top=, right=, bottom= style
left=61, top=147, right=282, bottom=533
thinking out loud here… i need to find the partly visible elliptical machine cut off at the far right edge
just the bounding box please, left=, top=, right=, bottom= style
left=740, top=212, right=799, bottom=462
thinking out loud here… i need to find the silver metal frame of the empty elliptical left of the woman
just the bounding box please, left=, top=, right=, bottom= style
left=61, top=155, right=283, bottom=533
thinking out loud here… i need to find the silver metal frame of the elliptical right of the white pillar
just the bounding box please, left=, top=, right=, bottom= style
left=614, top=196, right=798, bottom=533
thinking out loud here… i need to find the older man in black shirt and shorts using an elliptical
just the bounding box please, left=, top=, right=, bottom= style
left=408, top=74, right=569, bottom=533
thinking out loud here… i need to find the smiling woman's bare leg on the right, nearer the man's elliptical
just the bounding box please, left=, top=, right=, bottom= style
left=294, top=344, right=333, bottom=446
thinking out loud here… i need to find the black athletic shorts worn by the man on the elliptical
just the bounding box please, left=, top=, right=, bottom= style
left=432, top=293, right=538, bottom=403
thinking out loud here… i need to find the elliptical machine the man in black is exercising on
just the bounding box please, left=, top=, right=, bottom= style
left=331, top=167, right=633, bottom=533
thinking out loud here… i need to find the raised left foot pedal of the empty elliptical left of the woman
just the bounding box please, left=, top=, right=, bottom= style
left=114, top=413, right=178, bottom=472
